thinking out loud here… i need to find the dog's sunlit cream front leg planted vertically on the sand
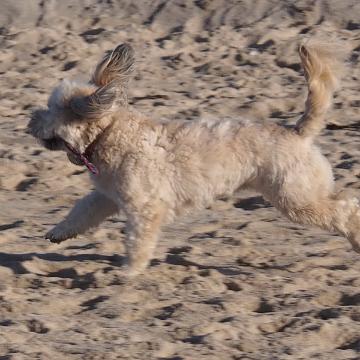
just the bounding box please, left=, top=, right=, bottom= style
left=125, top=201, right=166, bottom=276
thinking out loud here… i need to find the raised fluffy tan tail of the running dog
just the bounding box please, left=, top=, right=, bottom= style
left=295, top=44, right=344, bottom=138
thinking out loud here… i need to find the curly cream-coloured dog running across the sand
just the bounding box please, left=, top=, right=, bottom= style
left=28, top=43, right=360, bottom=276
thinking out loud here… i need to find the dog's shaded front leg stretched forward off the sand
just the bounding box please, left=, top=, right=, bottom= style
left=45, top=191, right=118, bottom=243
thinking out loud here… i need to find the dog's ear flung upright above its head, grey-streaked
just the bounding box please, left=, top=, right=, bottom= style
left=92, top=44, right=135, bottom=87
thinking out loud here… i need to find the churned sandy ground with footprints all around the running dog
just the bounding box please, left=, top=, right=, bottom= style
left=0, top=0, right=360, bottom=360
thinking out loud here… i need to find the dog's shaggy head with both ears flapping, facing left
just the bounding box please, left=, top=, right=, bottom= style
left=28, top=44, right=134, bottom=165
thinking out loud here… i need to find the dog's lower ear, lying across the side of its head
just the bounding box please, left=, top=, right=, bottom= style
left=70, top=83, right=117, bottom=119
